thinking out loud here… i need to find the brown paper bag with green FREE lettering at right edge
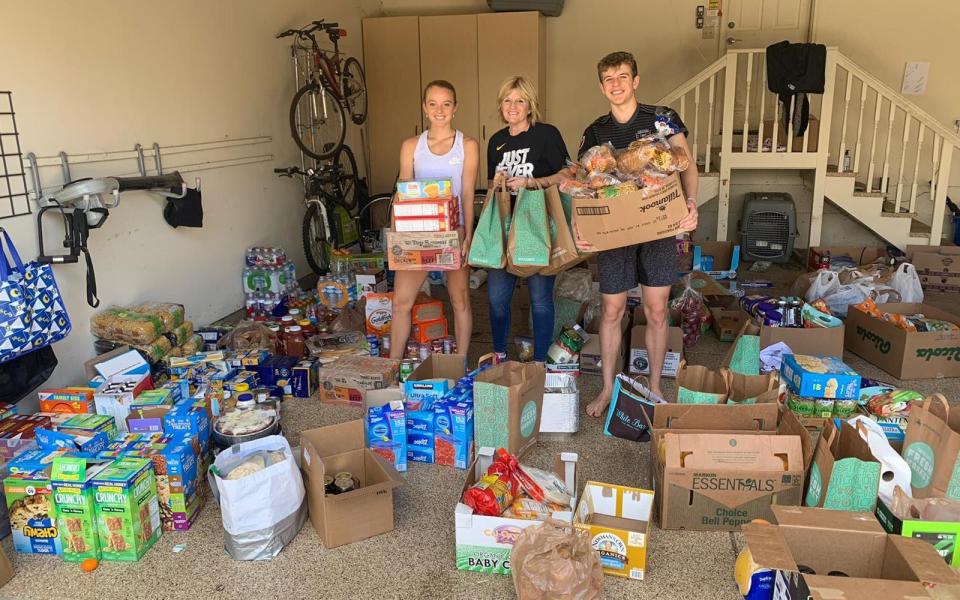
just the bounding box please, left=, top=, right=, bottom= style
left=903, top=394, right=960, bottom=500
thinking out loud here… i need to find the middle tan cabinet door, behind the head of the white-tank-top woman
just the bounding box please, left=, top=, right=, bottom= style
left=420, top=15, right=483, bottom=179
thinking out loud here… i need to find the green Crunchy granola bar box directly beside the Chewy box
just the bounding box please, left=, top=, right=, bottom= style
left=50, top=457, right=110, bottom=562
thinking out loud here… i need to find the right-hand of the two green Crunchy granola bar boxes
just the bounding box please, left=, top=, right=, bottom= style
left=91, top=458, right=160, bottom=561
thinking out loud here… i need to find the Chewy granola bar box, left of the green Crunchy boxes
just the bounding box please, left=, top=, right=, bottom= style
left=3, top=469, right=63, bottom=554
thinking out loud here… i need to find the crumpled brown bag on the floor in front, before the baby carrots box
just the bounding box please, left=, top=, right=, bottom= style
left=510, top=519, right=603, bottom=600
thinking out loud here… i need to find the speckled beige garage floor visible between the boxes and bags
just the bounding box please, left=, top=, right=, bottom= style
left=0, top=267, right=960, bottom=600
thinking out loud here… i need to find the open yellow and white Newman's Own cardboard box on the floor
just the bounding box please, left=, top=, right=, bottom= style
left=573, top=481, right=654, bottom=580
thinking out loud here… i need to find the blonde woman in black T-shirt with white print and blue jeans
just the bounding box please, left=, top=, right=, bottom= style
left=487, top=77, right=568, bottom=362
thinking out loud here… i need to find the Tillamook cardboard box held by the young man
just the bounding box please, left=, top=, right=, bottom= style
left=573, top=174, right=688, bottom=250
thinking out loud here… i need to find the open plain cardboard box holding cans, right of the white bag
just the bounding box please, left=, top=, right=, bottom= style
left=300, top=420, right=405, bottom=548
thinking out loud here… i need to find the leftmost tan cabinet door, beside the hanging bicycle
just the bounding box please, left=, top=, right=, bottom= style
left=363, top=17, right=423, bottom=194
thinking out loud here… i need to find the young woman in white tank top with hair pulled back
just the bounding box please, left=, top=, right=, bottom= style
left=390, top=80, right=480, bottom=358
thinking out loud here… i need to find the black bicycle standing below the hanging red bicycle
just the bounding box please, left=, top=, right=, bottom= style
left=273, top=146, right=359, bottom=275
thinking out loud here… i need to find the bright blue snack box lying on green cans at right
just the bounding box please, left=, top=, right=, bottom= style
left=780, top=354, right=860, bottom=400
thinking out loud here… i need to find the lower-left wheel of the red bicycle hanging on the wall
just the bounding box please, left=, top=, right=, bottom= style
left=290, top=82, right=347, bottom=160
